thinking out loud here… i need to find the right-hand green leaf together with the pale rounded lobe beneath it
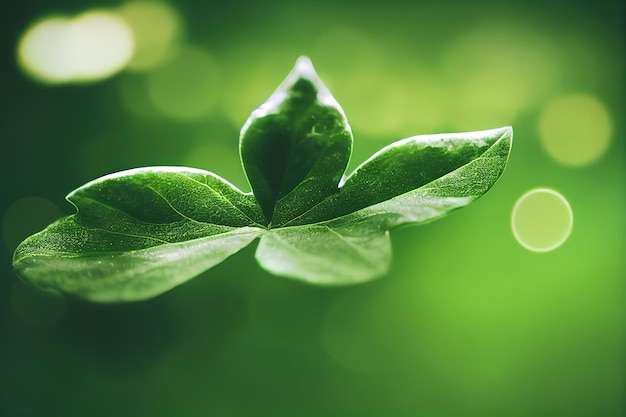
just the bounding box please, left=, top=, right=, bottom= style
left=256, top=128, right=512, bottom=284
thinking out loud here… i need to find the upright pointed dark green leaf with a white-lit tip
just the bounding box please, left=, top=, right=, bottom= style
left=240, top=57, right=352, bottom=227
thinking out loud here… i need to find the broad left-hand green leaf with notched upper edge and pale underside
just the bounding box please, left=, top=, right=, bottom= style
left=13, top=167, right=262, bottom=302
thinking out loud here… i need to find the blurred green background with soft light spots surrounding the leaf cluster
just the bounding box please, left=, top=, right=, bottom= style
left=0, top=0, right=626, bottom=417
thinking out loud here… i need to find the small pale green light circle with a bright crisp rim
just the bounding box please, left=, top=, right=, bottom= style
left=511, top=188, right=574, bottom=252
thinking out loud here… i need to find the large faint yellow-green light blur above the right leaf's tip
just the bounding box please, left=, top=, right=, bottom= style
left=442, top=20, right=560, bottom=130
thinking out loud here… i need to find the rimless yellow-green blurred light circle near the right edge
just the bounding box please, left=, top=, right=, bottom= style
left=538, top=93, right=613, bottom=166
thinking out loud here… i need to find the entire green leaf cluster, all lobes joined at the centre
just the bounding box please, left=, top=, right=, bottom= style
left=13, top=58, right=513, bottom=302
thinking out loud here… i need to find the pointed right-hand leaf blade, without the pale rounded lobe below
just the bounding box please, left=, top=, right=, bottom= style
left=287, top=127, right=513, bottom=227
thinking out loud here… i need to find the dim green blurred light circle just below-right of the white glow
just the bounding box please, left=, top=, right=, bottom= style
left=147, top=46, right=219, bottom=121
